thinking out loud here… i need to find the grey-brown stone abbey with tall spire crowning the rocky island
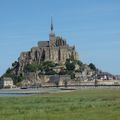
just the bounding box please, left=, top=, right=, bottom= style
left=18, top=20, right=79, bottom=72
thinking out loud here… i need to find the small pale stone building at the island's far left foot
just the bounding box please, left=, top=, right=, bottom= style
left=0, top=77, right=13, bottom=88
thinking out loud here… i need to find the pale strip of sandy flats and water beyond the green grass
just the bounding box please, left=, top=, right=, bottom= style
left=0, top=86, right=120, bottom=96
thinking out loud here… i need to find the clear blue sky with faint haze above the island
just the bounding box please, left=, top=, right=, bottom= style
left=0, top=0, right=120, bottom=76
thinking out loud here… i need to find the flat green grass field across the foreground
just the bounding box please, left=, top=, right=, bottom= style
left=0, top=89, right=120, bottom=120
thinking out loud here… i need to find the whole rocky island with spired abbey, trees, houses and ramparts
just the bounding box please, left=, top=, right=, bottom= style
left=1, top=19, right=120, bottom=88
